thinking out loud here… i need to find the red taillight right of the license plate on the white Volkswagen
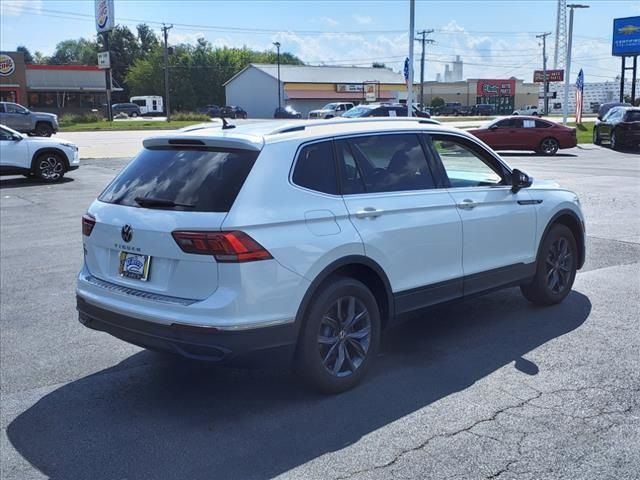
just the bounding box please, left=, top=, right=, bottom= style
left=171, top=231, right=273, bottom=263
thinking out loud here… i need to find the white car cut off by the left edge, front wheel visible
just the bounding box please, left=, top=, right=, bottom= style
left=0, top=125, right=80, bottom=182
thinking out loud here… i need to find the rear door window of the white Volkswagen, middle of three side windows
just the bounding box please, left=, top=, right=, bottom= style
left=349, top=133, right=435, bottom=192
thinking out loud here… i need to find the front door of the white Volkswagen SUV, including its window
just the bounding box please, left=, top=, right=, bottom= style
left=431, top=134, right=537, bottom=295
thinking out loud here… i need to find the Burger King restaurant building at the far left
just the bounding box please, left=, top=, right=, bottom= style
left=0, top=52, right=107, bottom=114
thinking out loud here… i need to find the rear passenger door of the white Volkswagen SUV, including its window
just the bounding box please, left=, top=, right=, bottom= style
left=336, top=133, right=462, bottom=313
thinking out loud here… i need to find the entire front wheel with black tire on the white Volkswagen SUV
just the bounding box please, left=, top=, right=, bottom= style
left=520, top=224, right=578, bottom=305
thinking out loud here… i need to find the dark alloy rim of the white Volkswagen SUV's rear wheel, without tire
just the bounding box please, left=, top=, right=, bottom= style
left=318, top=296, right=371, bottom=377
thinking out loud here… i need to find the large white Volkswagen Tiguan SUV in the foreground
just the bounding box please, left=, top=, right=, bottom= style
left=77, top=118, right=585, bottom=392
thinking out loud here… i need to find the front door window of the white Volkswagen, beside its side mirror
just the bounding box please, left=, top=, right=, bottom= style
left=431, top=135, right=504, bottom=188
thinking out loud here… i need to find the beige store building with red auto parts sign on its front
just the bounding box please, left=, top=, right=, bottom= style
left=422, top=77, right=540, bottom=115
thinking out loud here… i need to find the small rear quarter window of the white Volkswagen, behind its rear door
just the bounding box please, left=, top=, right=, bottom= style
left=293, top=142, right=338, bottom=195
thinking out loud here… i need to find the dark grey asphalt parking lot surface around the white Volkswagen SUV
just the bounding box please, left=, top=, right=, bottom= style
left=0, top=145, right=640, bottom=480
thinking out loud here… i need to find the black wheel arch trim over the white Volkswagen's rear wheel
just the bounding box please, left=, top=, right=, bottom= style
left=296, top=255, right=395, bottom=330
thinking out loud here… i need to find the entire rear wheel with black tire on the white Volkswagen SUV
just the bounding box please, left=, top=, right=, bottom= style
left=295, top=277, right=380, bottom=394
